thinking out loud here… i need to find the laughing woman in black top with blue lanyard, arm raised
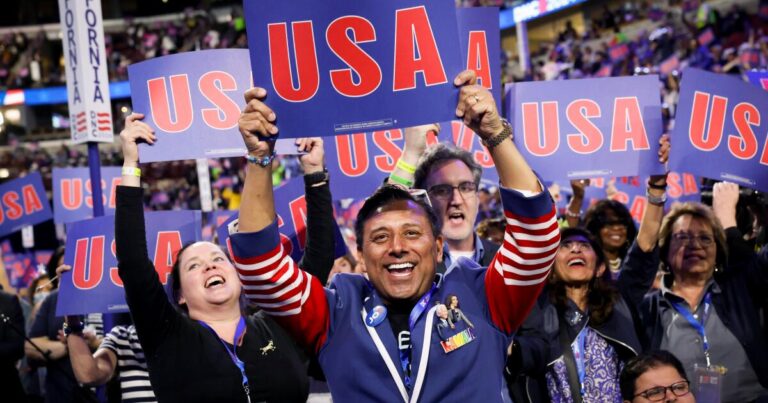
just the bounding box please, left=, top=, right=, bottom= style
left=115, top=114, right=308, bottom=402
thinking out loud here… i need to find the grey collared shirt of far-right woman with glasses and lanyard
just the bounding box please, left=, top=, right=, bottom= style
left=660, top=274, right=765, bottom=402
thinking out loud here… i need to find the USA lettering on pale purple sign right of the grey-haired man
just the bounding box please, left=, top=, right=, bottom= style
left=522, top=97, right=650, bottom=157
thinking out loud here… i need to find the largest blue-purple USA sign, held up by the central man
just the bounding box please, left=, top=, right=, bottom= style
left=243, top=0, right=462, bottom=138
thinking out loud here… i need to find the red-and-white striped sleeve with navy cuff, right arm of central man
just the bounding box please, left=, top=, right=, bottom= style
left=485, top=188, right=560, bottom=334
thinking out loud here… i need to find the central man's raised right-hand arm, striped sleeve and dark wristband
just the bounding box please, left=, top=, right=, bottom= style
left=454, top=70, right=560, bottom=334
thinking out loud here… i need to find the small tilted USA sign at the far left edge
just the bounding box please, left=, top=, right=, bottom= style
left=0, top=172, right=53, bottom=237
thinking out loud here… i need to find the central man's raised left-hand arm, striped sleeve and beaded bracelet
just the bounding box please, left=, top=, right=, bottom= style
left=228, top=88, right=330, bottom=352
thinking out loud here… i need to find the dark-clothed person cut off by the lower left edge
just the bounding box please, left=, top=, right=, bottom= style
left=0, top=290, right=26, bottom=402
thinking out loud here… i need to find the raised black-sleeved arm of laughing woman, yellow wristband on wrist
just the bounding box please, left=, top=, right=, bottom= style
left=115, top=113, right=179, bottom=354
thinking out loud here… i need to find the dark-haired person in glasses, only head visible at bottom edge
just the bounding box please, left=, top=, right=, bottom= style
left=619, top=350, right=696, bottom=403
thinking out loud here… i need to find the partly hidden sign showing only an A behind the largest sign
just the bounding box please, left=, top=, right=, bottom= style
left=456, top=7, right=501, bottom=111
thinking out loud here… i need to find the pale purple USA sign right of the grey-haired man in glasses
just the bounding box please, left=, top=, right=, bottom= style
left=514, top=75, right=663, bottom=179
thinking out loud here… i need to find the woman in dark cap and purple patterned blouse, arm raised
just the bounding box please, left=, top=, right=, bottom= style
left=508, top=136, right=669, bottom=403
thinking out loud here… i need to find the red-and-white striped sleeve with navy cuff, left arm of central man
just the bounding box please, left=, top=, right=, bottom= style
left=227, top=221, right=330, bottom=352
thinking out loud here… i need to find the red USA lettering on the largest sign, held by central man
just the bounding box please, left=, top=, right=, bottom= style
left=267, top=6, right=448, bottom=102
